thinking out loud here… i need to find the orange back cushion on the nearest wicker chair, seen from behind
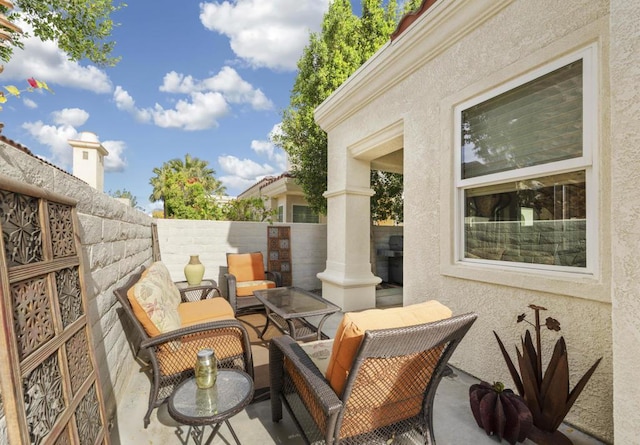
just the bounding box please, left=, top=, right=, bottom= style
left=326, top=300, right=451, bottom=396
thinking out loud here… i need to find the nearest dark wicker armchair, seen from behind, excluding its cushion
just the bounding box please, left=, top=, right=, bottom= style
left=270, top=314, right=477, bottom=445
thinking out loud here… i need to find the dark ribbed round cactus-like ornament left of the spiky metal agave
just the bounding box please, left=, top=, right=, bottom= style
left=469, top=382, right=533, bottom=445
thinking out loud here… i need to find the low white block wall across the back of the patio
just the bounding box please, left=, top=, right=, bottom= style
left=157, top=219, right=327, bottom=295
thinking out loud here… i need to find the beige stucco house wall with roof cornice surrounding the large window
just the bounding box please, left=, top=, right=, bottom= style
left=316, top=0, right=616, bottom=443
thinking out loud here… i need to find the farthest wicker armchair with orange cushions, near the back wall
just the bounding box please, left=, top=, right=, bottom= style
left=224, top=252, right=282, bottom=315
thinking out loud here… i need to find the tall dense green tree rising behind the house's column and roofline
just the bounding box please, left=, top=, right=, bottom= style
left=274, top=0, right=408, bottom=220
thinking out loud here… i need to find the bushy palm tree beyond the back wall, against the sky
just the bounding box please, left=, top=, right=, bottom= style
left=149, top=154, right=225, bottom=219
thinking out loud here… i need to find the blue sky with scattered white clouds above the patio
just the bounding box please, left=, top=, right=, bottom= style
left=0, top=0, right=372, bottom=211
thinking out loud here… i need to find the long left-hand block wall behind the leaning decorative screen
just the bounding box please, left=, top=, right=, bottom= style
left=0, top=141, right=153, bottom=421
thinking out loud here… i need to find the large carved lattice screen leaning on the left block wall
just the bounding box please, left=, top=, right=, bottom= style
left=0, top=177, right=109, bottom=445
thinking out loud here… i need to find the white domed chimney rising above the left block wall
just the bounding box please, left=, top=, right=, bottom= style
left=67, top=131, right=109, bottom=192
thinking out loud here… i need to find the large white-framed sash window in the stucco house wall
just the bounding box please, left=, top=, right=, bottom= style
left=456, top=46, right=596, bottom=272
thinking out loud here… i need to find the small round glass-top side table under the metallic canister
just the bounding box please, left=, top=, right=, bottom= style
left=168, top=369, right=253, bottom=445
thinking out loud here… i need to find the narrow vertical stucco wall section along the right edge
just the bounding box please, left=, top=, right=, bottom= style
left=610, top=0, right=640, bottom=444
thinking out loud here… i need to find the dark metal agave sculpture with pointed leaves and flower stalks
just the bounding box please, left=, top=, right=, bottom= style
left=493, top=304, right=602, bottom=444
